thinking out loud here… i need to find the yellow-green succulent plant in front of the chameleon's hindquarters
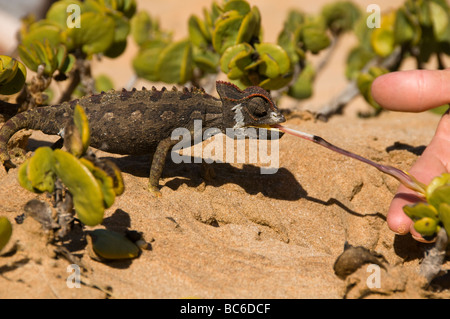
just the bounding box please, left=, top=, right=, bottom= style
left=18, top=105, right=124, bottom=226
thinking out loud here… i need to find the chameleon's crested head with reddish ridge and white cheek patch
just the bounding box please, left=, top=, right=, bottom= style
left=216, top=81, right=286, bottom=138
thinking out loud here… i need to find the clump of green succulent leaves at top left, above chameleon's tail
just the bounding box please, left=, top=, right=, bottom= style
left=21, top=0, right=136, bottom=63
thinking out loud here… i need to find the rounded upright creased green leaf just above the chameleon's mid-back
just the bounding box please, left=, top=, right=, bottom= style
left=156, top=40, right=193, bottom=84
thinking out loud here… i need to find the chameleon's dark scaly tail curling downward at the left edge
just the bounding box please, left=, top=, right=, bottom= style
left=0, top=107, right=66, bottom=170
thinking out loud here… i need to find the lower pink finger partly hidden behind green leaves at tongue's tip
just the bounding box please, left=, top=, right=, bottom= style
left=387, top=113, right=450, bottom=241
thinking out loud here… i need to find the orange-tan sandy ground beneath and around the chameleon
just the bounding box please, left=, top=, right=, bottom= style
left=0, top=0, right=448, bottom=298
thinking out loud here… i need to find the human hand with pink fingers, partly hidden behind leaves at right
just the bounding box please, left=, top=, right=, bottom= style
left=372, top=69, right=450, bottom=242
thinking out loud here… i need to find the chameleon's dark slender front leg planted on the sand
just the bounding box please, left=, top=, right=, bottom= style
left=149, top=137, right=178, bottom=197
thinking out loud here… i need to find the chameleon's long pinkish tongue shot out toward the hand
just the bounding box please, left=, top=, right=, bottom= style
left=272, top=125, right=426, bottom=196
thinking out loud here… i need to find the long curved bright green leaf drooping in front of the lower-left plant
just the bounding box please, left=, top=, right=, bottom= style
left=53, top=149, right=104, bottom=226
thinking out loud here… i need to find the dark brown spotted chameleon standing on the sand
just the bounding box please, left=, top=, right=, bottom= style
left=0, top=81, right=285, bottom=196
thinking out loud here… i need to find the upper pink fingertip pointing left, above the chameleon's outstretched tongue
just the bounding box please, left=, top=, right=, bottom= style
left=372, top=69, right=450, bottom=112
